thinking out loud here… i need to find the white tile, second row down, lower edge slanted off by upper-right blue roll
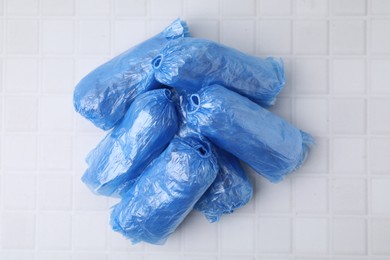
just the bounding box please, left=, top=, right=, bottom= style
left=221, top=20, right=255, bottom=54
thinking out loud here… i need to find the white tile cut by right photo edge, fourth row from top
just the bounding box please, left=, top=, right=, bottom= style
left=369, top=98, right=390, bottom=134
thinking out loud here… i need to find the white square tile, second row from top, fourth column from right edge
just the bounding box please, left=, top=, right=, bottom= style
left=257, top=20, right=292, bottom=55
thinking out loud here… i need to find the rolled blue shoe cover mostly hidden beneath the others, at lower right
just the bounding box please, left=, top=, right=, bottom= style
left=194, top=148, right=253, bottom=222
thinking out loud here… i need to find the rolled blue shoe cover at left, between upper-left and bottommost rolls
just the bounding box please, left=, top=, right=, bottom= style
left=82, top=89, right=178, bottom=196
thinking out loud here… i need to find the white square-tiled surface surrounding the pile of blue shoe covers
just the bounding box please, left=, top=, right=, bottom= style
left=0, top=0, right=390, bottom=260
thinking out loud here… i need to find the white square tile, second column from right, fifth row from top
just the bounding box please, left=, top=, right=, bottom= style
left=332, top=138, right=366, bottom=174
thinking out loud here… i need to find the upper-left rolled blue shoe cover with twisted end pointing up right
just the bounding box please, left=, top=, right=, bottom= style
left=73, top=19, right=189, bottom=130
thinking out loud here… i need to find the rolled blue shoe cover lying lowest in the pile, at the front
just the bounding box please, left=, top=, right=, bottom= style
left=111, top=137, right=218, bottom=244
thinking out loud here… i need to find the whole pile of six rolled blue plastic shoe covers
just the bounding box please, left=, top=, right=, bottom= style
left=74, top=19, right=313, bottom=244
